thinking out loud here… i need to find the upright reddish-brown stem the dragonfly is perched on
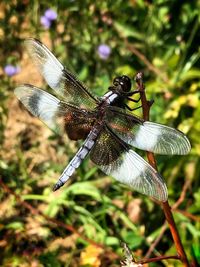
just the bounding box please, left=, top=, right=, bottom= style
left=135, top=72, right=190, bottom=267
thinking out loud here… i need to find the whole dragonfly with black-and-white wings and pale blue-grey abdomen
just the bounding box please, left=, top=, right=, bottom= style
left=15, top=38, right=191, bottom=202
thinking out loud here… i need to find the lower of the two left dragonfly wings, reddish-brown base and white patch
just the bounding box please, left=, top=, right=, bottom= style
left=15, top=84, right=93, bottom=137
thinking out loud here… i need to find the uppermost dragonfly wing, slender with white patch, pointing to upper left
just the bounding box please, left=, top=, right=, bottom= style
left=25, top=38, right=98, bottom=110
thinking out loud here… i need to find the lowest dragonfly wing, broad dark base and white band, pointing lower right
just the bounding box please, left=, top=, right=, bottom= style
left=90, top=129, right=167, bottom=202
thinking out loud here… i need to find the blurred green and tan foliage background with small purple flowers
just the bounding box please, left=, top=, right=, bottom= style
left=0, top=0, right=200, bottom=267
